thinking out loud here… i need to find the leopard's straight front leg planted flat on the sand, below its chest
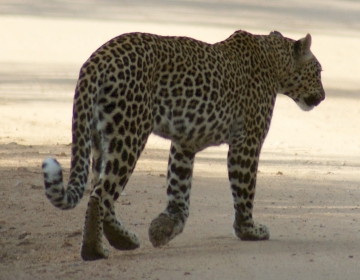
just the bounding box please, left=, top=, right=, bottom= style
left=228, top=138, right=270, bottom=241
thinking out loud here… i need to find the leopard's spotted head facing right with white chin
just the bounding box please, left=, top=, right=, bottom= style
left=280, top=34, right=325, bottom=111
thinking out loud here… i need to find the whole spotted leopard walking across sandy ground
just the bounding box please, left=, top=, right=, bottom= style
left=42, top=30, right=325, bottom=261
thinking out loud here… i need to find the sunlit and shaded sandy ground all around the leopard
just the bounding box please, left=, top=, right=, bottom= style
left=0, top=0, right=360, bottom=279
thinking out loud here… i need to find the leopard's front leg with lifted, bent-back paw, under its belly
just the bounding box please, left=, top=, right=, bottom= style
left=149, top=143, right=195, bottom=247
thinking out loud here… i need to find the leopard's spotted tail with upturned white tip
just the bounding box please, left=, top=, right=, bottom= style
left=42, top=71, right=92, bottom=209
